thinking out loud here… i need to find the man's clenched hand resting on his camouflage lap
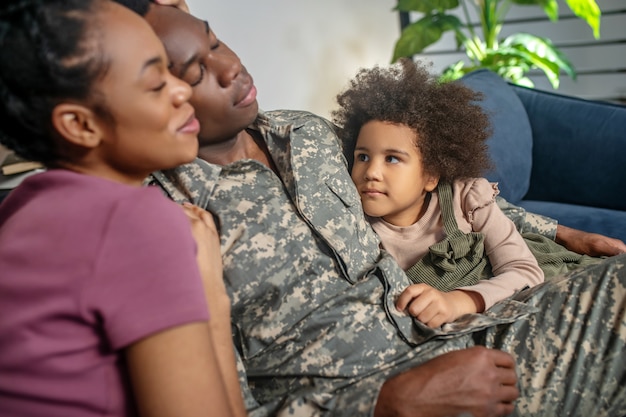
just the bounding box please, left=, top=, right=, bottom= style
left=374, top=346, right=519, bottom=417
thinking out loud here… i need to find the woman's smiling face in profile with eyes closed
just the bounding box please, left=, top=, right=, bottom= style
left=89, top=2, right=199, bottom=182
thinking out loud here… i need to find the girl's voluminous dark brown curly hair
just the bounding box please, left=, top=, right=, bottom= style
left=331, top=58, right=492, bottom=182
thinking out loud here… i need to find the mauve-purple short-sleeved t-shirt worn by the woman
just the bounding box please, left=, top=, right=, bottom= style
left=0, top=170, right=208, bottom=417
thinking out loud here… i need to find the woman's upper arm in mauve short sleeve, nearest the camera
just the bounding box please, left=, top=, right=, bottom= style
left=99, top=193, right=243, bottom=417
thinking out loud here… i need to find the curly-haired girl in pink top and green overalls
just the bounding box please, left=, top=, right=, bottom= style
left=333, top=59, right=543, bottom=327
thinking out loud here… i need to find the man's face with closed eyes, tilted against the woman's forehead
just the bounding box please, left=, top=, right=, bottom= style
left=146, top=5, right=258, bottom=145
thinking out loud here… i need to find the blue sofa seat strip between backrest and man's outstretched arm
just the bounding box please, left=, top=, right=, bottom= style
left=519, top=200, right=626, bottom=242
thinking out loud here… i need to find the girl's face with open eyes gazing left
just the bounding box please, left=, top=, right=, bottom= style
left=352, top=120, right=439, bottom=226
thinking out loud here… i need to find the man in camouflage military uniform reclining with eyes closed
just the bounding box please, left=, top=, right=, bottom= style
left=130, top=1, right=626, bottom=416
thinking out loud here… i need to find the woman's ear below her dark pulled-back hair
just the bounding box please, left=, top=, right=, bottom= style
left=52, top=103, right=103, bottom=148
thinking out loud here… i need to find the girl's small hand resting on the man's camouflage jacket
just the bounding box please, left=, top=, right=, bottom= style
left=396, top=284, right=484, bottom=328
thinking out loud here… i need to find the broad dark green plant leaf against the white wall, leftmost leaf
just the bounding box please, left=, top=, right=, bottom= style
left=391, top=13, right=462, bottom=62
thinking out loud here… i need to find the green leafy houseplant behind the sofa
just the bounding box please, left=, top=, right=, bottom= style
left=392, top=0, right=601, bottom=89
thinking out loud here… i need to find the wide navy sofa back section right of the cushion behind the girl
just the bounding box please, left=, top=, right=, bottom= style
left=511, top=85, right=626, bottom=210
